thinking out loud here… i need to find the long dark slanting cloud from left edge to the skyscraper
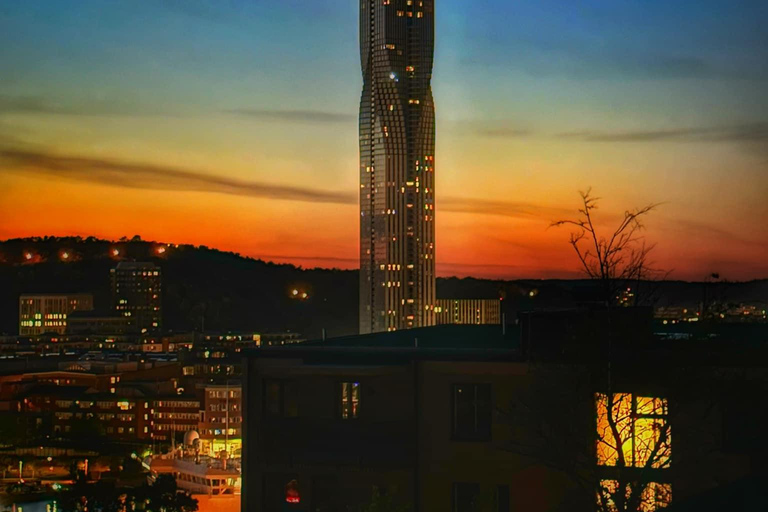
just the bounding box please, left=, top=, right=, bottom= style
left=0, top=149, right=356, bottom=204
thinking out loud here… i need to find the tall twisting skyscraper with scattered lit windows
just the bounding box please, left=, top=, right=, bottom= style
left=360, top=0, right=435, bottom=333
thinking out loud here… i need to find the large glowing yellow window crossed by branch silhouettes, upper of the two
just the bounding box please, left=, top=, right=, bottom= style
left=595, top=393, right=672, bottom=468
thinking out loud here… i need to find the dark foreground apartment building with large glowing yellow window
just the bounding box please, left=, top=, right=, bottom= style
left=243, top=313, right=768, bottom=512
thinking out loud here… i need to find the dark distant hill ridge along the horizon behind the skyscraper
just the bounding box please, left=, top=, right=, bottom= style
left=0, top=237, right=768, bottom=338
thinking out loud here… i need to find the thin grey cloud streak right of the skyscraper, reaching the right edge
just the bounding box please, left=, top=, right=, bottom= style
left=557, top=122, right=768, bottom=142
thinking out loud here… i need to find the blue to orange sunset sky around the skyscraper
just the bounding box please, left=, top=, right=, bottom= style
left=0, top=0, right=768, bottom=280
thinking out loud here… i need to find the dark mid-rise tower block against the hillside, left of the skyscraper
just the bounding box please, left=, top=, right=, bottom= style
left=110, top=262, right=162, bottom=333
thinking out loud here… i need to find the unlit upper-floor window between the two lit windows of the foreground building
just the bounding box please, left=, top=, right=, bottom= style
left=452, top=384, right=491, bottom=441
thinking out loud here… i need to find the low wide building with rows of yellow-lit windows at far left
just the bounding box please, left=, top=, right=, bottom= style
left=19, top=293, right=93, bottom=336
